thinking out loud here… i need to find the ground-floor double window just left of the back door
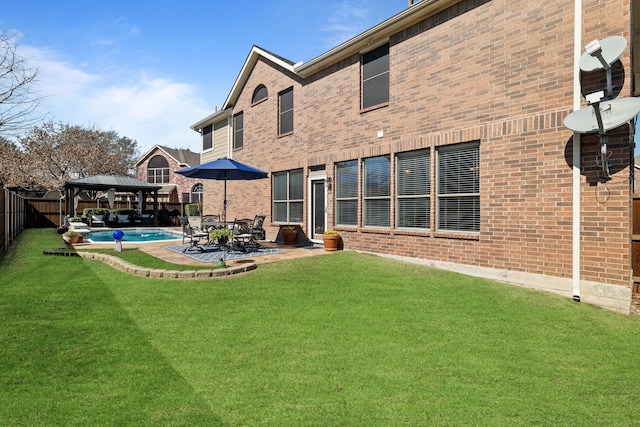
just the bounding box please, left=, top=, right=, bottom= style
left=273, top=169, right=304, bottom=223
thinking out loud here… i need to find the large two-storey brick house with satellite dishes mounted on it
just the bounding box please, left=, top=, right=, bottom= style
left=193, top=0, right=640, bottom=312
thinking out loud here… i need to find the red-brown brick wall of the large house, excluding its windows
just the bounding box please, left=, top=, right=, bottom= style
left=219, top=0, right=630, bottom=294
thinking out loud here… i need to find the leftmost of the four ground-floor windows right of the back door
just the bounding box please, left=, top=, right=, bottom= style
left=336, top=160, right=358, bottom=226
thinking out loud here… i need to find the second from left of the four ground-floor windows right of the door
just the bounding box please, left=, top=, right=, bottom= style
left=362, top=156, right=391, bottom=227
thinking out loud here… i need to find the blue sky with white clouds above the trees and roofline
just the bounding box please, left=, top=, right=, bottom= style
left=0, top=0, right=408, bottom=154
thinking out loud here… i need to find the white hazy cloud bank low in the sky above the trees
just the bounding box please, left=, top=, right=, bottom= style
left=21, top=46, right=211, bottom=153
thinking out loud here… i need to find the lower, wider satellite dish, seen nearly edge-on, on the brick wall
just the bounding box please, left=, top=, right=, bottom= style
left=562, top=98, right=640, bottom=133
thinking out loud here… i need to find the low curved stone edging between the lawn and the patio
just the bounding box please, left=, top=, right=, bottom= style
left=44, top=249, right=258, bottom=279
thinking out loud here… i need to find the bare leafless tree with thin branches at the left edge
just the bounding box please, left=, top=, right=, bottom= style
left=0, top=31, right=41, bottom=138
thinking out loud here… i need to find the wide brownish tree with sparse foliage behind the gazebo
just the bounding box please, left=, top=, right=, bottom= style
left=0, top=121, right=139, bottom=191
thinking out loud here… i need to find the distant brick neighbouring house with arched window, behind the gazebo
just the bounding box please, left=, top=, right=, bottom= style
left=136, top=145, right=203, bottom=203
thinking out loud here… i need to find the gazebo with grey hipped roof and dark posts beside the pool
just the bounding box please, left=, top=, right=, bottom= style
left=64, top=175, right=162, bottom=226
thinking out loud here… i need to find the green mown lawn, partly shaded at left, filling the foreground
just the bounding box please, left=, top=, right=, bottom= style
left=0, top=230, right=640, bottom=426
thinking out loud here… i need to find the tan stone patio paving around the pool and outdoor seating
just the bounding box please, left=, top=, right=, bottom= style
left=74, top=227, right=331, bottom=267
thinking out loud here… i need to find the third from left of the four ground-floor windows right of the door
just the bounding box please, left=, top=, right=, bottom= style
left=396, top=150, right=431, bottom=229
